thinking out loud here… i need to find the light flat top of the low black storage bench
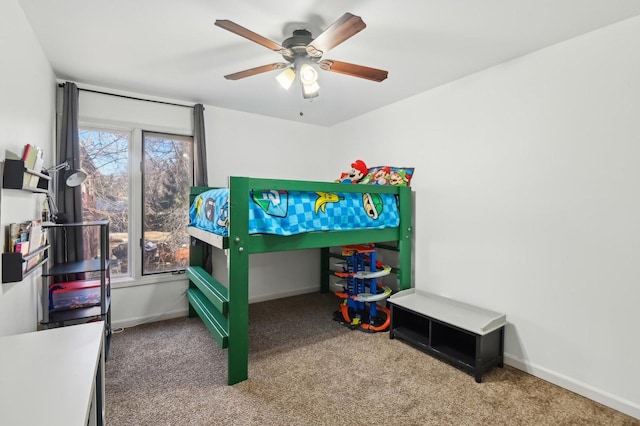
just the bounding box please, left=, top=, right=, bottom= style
left=389, top=288, right=507, bottom=336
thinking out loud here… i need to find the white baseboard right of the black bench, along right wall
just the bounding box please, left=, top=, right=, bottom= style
left=504, top=353, right=640, bottom=419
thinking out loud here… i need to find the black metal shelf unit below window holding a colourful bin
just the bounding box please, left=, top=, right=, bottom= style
left=41, top=220, right=111, bottom=354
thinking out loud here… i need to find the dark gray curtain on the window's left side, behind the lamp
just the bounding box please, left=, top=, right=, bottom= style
left=54, top=82, right=84, bottom=262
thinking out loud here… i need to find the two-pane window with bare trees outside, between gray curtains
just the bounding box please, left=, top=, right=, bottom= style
left=79, top=128, right=193, bottom=277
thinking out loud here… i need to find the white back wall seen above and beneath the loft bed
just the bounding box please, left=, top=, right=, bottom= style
left=205, top=106, right=332, bottom=302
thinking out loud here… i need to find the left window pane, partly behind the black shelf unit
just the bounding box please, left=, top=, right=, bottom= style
left=79, top=129, right=130, bottom=276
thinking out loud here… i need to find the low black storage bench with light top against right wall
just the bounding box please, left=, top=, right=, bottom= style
left=389, top=288, right=506, bottom=383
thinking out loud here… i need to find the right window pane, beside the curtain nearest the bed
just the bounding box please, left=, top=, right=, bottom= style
left=142, top=132, right=193, bottom=274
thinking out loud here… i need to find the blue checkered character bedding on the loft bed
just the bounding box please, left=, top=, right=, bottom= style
left=189, top=188, right=400, bottom=236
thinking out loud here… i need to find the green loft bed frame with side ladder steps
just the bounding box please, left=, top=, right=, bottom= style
left=186, top=177, right=413, bottom=385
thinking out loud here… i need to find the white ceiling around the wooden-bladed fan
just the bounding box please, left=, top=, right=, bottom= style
left=19, top=0, right=640, bottom=126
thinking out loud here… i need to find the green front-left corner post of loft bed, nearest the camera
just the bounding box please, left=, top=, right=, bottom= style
left=227, top=177, right=251, bottom=385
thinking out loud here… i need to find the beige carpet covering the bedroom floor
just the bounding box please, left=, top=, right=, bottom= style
left=106, top=294, right=640, bottom=426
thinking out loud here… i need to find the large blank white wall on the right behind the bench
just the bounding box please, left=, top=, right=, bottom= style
left=329, top=17, right=640, bottom=417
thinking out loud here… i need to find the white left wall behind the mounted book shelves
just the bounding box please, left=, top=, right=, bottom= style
left=0, top=0, right=55, bottom=336
